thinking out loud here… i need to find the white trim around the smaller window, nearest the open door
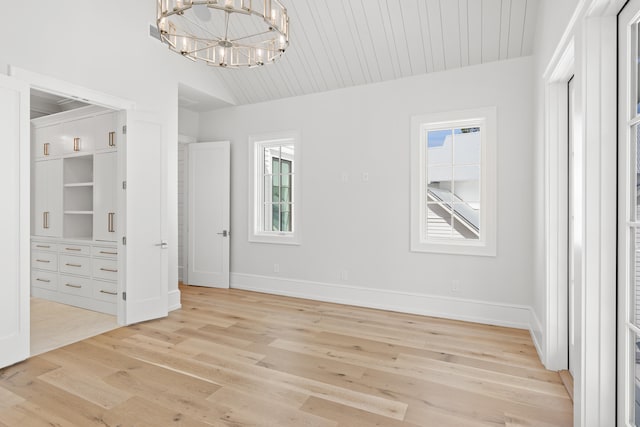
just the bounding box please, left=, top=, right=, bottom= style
left=248, top=131, right=302, bottom=245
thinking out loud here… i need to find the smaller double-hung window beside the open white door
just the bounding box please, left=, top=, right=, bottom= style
left=249, top=132, right=300, bottom=244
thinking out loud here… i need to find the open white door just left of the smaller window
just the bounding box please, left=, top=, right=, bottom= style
left=188, top=141, right=231, bottom=288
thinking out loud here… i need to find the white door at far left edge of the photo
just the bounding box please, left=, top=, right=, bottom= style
left=0, top=75, right=31, bottom=368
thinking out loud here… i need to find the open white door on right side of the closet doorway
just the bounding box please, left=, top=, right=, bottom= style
left=119, top=111, right=168, bottom=324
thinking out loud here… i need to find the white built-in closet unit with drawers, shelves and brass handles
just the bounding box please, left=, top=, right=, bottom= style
left=31, top=105, right=123, bottom=315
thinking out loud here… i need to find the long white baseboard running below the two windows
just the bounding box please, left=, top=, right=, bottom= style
left=231, top=273, right=532, bottom=330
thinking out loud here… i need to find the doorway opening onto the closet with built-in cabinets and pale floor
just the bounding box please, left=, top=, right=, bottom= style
left=30, top=88, right=120, bottom=356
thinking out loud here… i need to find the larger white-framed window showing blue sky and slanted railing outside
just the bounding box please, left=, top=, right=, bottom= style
left=411, top=108, right=497, bottom=256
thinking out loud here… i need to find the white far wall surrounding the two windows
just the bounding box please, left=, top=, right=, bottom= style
left=199, top=58, right=534, bottom=327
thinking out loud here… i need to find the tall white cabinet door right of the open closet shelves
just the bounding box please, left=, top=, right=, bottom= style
left=93, top=152, right=118, bottom=242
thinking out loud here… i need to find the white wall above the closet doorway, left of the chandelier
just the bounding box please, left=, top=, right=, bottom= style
left=0, top=0, right=233, bottom=312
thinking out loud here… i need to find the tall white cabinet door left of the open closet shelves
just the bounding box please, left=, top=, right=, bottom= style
left=33, top=159, right=62, bottom=237
